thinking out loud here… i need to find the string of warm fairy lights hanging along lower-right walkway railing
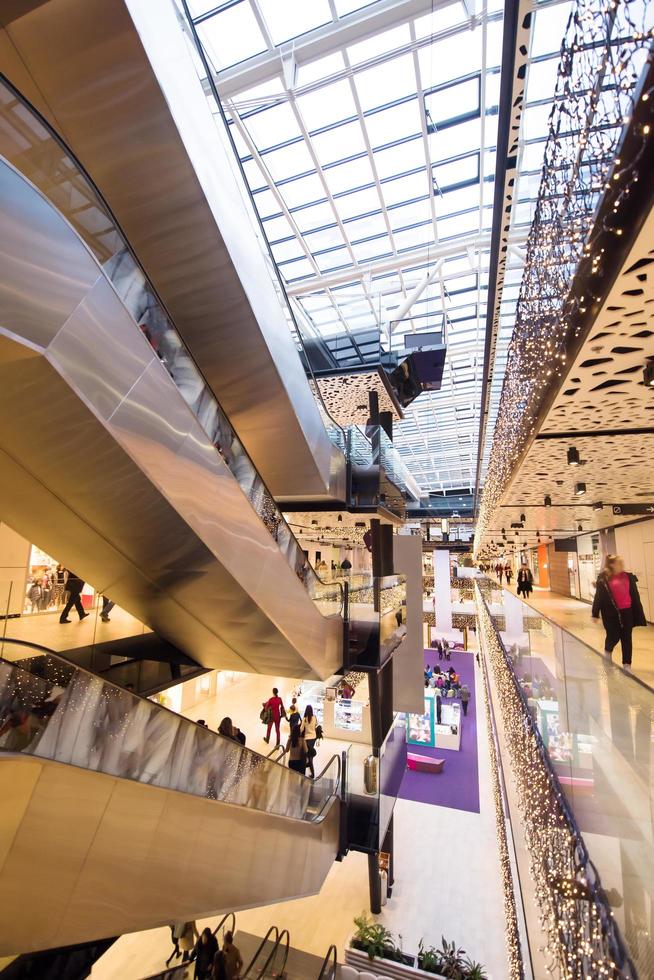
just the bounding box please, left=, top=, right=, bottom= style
left=476, top=580, right=637, bottom=980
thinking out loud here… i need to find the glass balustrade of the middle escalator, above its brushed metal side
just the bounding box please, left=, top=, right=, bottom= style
left=0, top=75, right=342, bottom=614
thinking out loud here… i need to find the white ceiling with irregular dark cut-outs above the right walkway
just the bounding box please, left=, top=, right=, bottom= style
left=482, top=212, right=654, bottom=546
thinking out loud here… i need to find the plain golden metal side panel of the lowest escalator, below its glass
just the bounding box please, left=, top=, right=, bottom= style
left=0, top=753, right=339, bottom=955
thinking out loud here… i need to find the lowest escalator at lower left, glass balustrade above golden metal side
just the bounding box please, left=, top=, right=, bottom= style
left=0, top=651, right=341, bottom=962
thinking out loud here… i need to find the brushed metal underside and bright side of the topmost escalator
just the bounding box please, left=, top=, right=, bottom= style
left=0, top=0, right=340, bottom=499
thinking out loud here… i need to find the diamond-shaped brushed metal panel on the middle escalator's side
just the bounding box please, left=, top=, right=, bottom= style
left=47, top=278, right=155, bottom=419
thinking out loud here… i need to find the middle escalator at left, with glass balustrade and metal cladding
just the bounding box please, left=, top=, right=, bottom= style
left=0, top=82, right=343, bottom=678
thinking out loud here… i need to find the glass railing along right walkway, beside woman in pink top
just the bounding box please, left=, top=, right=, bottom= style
left=479, top=579, right=654, bottom=977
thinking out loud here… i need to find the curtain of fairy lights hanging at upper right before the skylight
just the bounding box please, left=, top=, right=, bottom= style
left=474, top=0, right=654, bottom=555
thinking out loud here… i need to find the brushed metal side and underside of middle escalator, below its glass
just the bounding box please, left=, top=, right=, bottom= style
left=0, top=163, right=340, bottom=676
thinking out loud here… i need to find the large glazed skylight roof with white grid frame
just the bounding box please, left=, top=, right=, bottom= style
left=191, top=0, right=571, bottom=490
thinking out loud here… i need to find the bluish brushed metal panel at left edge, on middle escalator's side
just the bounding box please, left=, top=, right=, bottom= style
left=0, top=159, right=99, bottom=347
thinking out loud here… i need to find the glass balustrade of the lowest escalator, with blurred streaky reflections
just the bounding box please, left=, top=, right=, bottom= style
left=0, top=644, right=340, bottom=821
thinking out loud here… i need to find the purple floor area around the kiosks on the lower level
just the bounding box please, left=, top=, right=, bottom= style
left=399, top=650, right=479, bottom=813
